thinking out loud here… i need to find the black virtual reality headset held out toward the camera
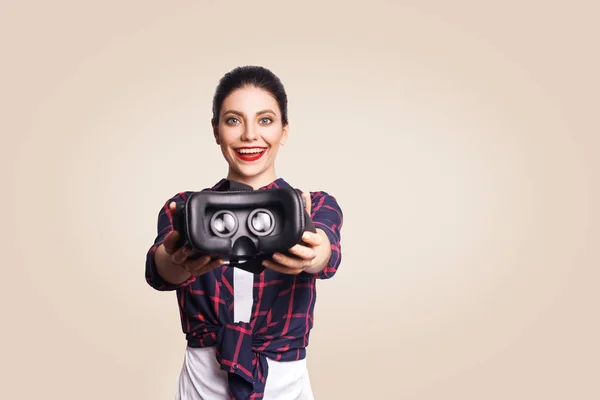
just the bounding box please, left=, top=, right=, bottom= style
left=173, top=187, right=316, bottom=273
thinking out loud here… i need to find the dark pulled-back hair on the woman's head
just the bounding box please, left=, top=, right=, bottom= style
left=212, top=65, right=288, bottom=126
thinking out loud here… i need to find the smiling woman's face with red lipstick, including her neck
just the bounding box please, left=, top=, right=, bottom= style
left=213, top=86, right=288, bottom=189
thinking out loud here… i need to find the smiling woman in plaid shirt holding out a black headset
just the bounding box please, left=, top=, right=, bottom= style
left=146, top=66, right=343, bottom=400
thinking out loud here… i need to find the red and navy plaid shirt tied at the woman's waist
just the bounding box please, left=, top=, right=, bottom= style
left=146, top=178, right=343, bottom=400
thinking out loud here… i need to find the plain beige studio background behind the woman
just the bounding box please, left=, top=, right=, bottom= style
left=0, top=0, right=600, bottom=400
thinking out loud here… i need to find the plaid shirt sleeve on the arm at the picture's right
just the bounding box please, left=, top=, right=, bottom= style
left=311, top=192, right=344, bottom=279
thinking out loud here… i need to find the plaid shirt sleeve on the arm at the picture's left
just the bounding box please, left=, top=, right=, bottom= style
left=146, top=192, right=196, bottom=291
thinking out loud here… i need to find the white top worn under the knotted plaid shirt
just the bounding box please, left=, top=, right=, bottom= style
left=176, top=268, right=314, bottom=400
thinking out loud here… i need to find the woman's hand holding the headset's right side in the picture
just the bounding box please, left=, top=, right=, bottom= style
left=262, top=193, right=331, bottom=275
